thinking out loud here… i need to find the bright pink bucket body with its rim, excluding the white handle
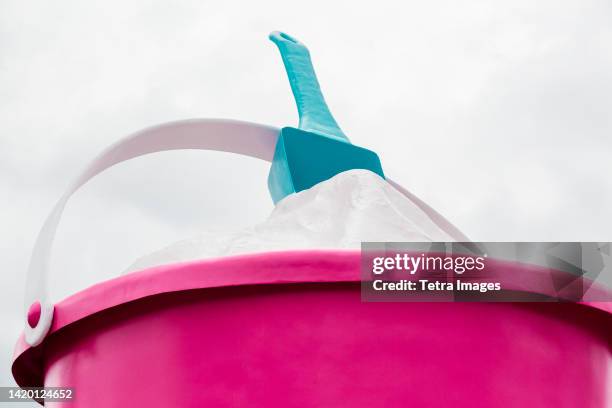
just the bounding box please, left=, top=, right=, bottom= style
left=13, top=251, right=612, bottom=408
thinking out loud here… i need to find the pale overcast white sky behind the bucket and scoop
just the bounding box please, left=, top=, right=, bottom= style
left=0, top=0, right=612, bottom=406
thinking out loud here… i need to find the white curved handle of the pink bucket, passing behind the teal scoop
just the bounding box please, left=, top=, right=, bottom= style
left=25, top=119, right=468, bottom=346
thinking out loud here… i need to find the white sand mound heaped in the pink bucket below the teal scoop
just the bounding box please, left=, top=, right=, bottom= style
left=127, top=170, right=453, bottom=272
